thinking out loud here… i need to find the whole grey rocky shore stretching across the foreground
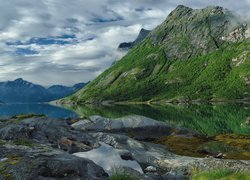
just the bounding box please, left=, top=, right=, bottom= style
left=0, top=116, right=250, bottom=179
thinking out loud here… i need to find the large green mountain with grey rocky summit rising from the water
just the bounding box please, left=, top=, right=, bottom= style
left=61, top=5, right=250, bottom=103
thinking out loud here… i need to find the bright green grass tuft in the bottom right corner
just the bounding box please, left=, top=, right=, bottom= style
left=191, top=169, right=250, bottom=180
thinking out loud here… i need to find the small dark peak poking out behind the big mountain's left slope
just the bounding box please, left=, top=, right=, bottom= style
left=118, top=28, right=150, bottom=51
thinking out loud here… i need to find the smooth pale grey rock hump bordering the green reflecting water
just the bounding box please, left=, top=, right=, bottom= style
left=71, top=115, right=196, bottom=140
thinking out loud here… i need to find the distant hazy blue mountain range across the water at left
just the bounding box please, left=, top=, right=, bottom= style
left=0, top=78, right=88, bottom=103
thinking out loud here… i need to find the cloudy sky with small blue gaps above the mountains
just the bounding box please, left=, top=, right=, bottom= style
left=0, top=0, right=250, bottom=86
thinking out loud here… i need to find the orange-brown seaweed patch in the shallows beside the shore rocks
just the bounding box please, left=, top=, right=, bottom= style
left=153, top=134, right=250, bottom=160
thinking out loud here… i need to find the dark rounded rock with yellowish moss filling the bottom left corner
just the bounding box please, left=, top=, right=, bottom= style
left=0, top=146, right=108, bottom=180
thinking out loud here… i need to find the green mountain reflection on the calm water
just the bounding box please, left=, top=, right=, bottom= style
left=68, top=104, right=250, bottom=136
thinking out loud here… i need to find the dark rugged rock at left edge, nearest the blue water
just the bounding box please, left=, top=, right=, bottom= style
left=0, top=117, right=99, bottom=153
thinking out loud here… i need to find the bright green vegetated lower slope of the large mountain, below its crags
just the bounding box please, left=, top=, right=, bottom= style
left=63, top=40, right=250, bottom=103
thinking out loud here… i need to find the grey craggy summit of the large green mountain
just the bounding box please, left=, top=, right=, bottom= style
left=150, top=5, right=242, bottom=59
